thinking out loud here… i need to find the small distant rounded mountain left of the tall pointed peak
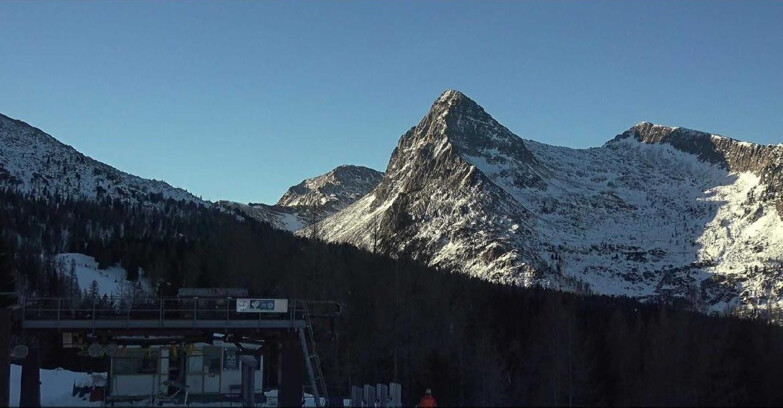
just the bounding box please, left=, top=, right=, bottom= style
left=220, top=165, right=383, bottom=232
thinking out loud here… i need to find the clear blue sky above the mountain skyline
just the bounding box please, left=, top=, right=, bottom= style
left=0, top=1, right=783, bottom=202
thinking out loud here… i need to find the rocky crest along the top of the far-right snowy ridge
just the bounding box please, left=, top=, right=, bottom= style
left=616, top=122, right=783, bottom=217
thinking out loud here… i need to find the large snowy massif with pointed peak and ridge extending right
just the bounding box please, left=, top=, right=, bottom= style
left=310, top=91, right=783, bottom=311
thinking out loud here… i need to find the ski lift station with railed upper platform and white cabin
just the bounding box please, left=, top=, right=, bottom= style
left=0, top=289, right=358, bottom=406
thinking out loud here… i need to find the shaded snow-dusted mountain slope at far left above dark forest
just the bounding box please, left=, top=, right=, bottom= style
left=0, top=114, right=209, bottom=205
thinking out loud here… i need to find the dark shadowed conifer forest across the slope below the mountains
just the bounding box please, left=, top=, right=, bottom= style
left=0, top=190, right=783, bottom=406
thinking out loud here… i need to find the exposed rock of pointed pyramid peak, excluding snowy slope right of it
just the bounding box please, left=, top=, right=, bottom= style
left=312, top=91, right=545, bottom=284
